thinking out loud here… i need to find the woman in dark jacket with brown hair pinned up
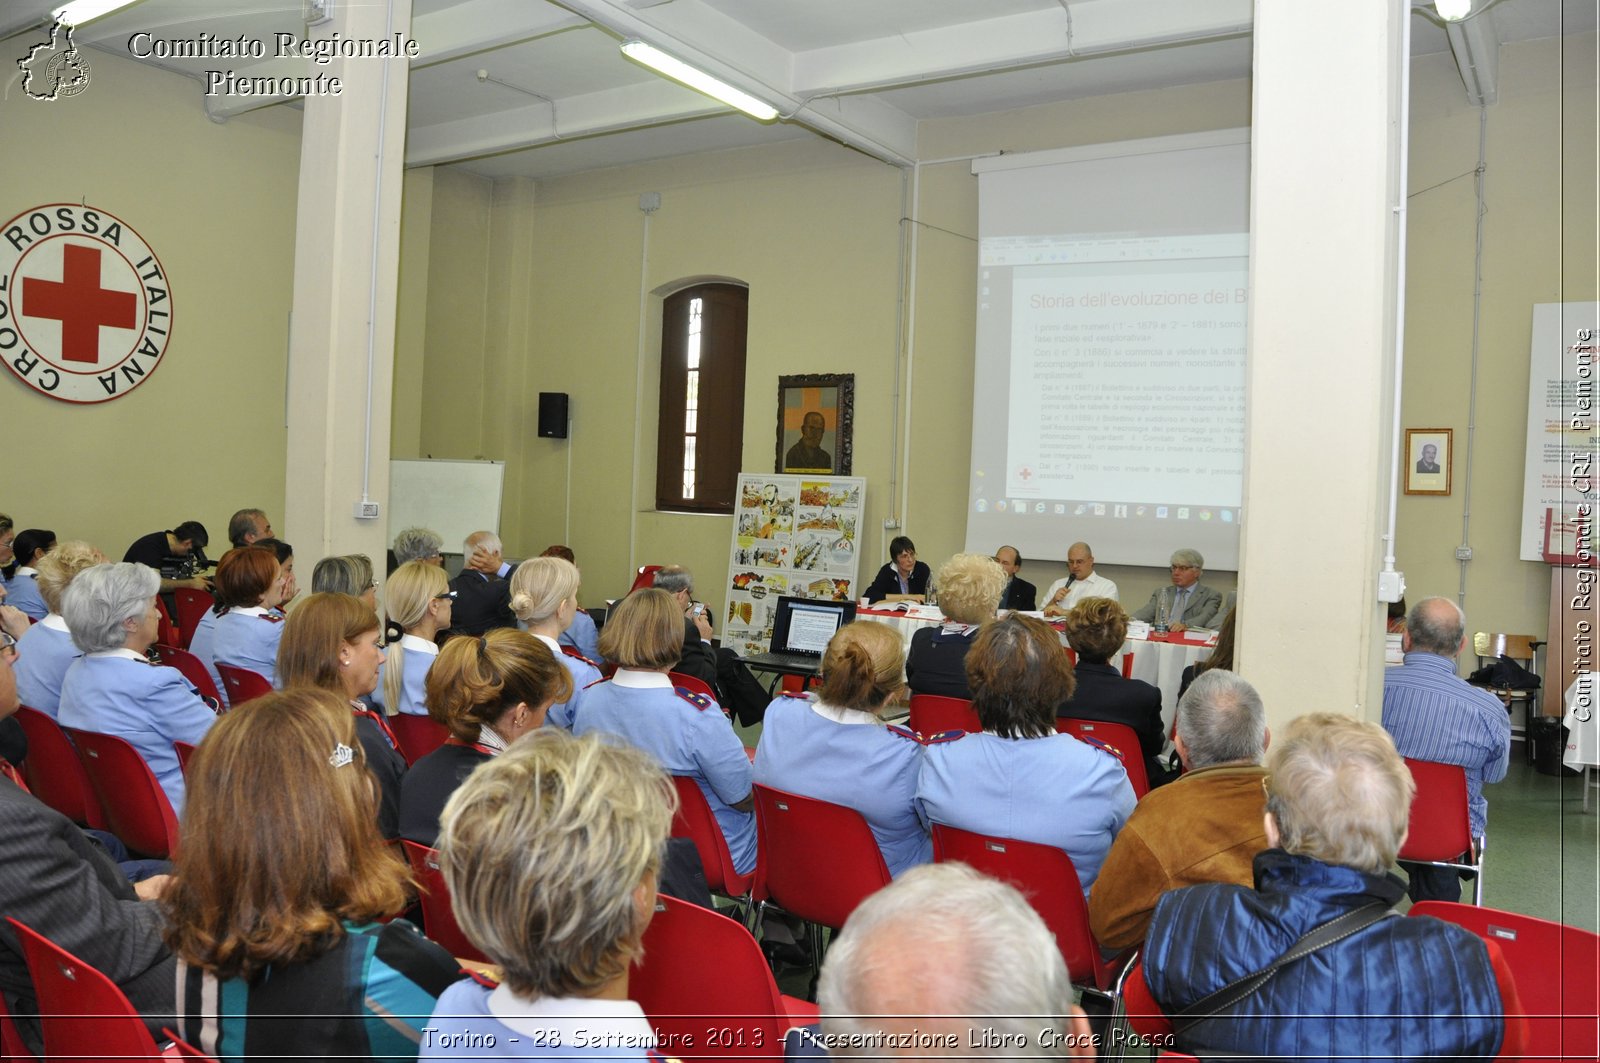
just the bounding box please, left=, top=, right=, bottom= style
left=395, top=630, right=571, bottom=848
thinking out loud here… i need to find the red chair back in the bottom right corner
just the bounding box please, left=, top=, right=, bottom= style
left=1406, top=901, right=1600, bottom=1060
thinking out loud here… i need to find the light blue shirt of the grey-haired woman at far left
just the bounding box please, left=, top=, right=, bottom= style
left=58, top=650, right=216, bottom=816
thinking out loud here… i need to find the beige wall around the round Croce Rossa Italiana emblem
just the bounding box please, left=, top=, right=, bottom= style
left=0, top=51, right=301, bottom=559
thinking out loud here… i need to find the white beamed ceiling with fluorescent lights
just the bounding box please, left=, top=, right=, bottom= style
left=0, top=0, right=1597, bottom=178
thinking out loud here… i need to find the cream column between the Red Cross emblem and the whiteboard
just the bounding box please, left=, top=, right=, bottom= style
left=283, top=0, right=411, bottom=572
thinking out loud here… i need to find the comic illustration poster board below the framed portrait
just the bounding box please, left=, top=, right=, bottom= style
left=718, top=472, right=867, bottom=656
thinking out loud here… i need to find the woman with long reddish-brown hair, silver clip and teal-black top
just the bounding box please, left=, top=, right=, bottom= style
left=162, top=687, right=461, bottom=1060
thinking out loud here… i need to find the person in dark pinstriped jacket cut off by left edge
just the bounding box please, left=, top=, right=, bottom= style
left=0, top=653, right=173, bottom=1058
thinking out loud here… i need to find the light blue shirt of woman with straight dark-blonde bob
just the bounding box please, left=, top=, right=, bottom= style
left=573, top=668, right=755, bottom=874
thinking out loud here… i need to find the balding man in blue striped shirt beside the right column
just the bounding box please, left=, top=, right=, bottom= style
left=1384, top=597, right=1510, bottom=901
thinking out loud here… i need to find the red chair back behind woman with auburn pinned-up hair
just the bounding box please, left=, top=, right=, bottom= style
left=755, top=783, right=890, bottom=930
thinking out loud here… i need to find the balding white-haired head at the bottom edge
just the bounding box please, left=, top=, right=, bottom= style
left=816, top=863, right=1094, bottom=1060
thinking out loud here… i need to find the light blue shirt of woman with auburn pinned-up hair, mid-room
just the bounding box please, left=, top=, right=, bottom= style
left=755, top=695, right=933, bottom=876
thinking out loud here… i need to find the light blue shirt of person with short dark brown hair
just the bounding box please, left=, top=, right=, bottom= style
left=917, top=733, right=1134, bottom=897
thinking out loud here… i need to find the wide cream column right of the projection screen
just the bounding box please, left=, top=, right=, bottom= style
left=1238, top=0, right=1410, bottom=725
